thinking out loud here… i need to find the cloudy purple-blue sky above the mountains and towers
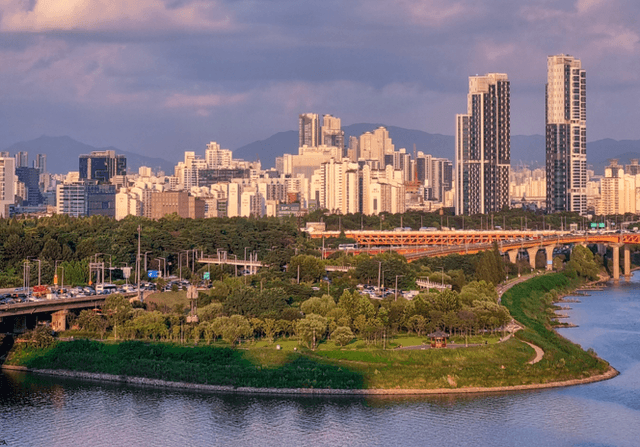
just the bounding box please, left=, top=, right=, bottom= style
left=0, top=0, right=640, bottom=159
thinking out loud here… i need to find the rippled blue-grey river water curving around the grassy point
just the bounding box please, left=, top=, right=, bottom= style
left=0, top=274, right=640, bottom=447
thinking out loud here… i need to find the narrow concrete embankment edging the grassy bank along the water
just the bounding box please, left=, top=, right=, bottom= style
left=2, top=365, right=619, bottom=396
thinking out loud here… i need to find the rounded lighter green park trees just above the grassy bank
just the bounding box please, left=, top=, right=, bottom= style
left=71, top=281, right=511, bottom=348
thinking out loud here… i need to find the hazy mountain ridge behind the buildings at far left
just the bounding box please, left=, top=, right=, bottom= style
left=5, top=135, right=174, bottom=174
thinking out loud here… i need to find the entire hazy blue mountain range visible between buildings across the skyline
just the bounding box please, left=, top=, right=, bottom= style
left=5, top=129, right=640, bottom=174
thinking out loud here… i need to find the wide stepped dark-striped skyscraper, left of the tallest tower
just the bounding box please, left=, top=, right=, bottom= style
left=455, top=73, right=511, bottom=214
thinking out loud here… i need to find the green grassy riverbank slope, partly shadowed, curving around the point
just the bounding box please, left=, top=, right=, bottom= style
left=7, top=274, right=608, bottom=389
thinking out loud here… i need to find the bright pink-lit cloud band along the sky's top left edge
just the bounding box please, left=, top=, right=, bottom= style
left=0, top=0, right=233, bottom=33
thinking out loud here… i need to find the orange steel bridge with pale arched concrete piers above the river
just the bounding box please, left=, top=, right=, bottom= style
left=309, top=230, right=640, bottom=279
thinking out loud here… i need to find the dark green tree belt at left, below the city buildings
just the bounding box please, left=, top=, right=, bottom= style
left=0, top=215, right=302, bottom=287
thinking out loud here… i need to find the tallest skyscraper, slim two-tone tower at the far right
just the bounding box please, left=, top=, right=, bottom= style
left=545, top=54, right=587, bottom=214
